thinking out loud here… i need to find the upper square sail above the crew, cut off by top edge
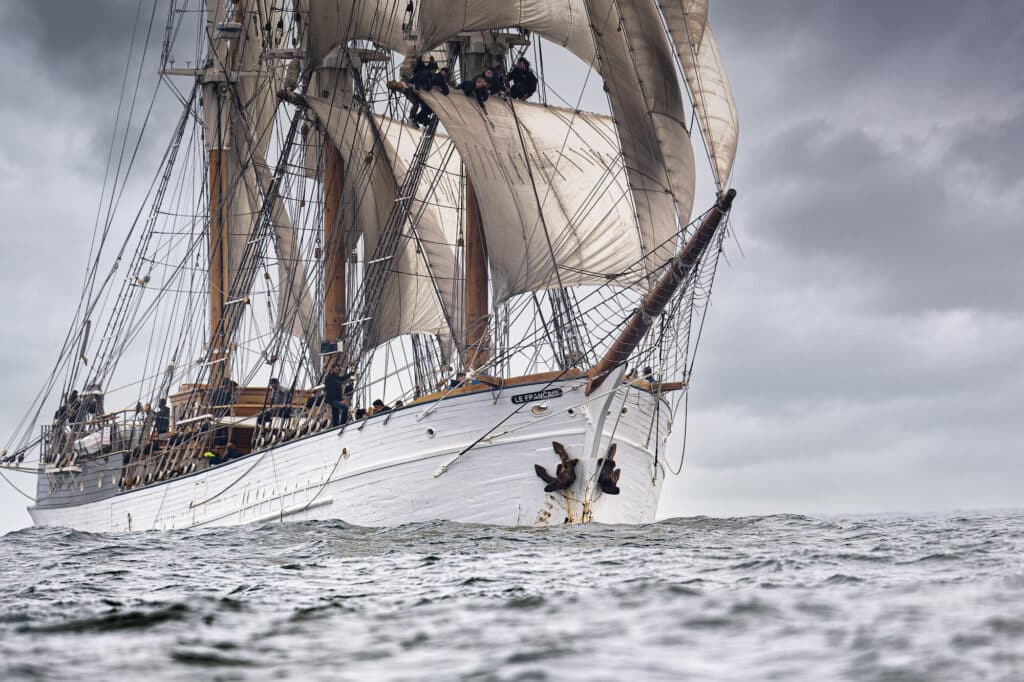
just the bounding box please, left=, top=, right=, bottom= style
left=416, top=0, right=594, bottom=63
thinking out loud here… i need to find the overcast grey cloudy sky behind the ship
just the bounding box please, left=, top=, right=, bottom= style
left=0, top=0, right=1024, bottom=531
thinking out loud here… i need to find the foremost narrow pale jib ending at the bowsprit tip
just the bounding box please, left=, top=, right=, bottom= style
left=669, top=24, right=739, bottom=187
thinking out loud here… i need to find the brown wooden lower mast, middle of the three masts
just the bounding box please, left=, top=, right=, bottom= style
left=324, top=139, right=348, bottom=348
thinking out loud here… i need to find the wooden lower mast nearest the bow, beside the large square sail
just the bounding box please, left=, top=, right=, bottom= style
left=465, top=175, right=490, bottom=370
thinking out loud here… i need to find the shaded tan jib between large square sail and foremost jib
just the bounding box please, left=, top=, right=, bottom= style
left=586, top=0, right=695, bottom=270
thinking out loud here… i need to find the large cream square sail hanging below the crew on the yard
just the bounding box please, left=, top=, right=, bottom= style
left=420, top=92, right=663, bottom=304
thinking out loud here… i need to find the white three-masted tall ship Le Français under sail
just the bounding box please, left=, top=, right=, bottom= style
left=0, top=0, right=738, bottom=531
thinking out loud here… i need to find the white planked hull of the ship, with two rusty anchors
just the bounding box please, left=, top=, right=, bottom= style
left=29, top=379, right=670, bottom=531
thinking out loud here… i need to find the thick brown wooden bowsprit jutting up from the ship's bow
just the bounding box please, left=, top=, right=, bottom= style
left=587, top=189, right=736, bottom=395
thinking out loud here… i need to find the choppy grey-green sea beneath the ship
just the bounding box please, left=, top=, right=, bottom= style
left=0, top=512, right=1024, bottom=682
